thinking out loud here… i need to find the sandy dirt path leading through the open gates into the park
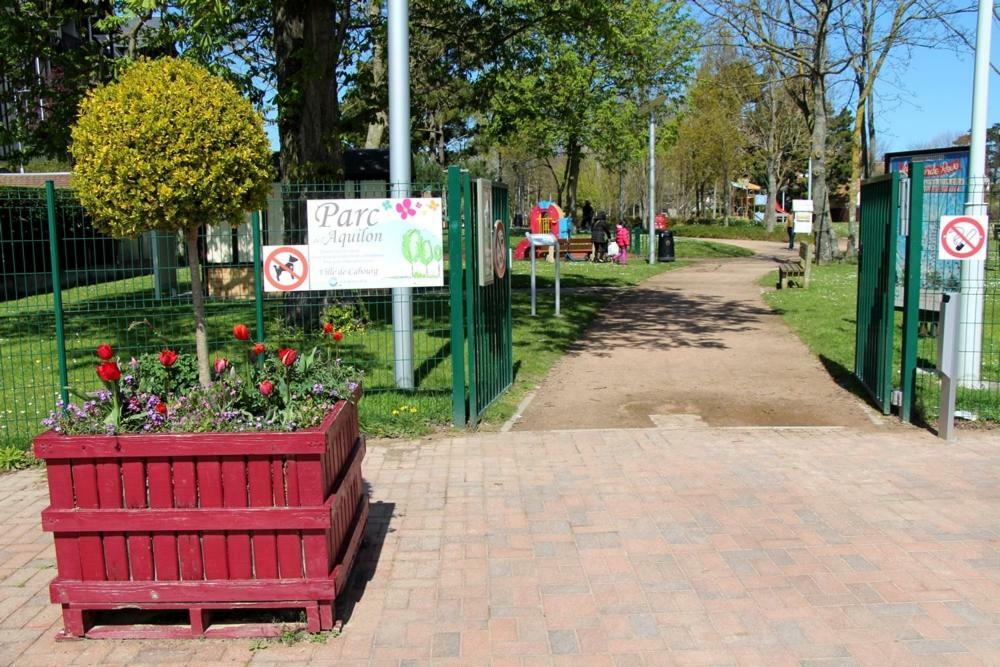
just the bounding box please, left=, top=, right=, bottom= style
left=514, top=241, right=881, bottom=431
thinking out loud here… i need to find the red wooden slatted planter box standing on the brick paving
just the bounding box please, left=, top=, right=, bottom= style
left=34, top=394, right=368, bottom=637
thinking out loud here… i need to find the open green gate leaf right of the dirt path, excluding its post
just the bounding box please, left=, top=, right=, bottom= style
left=854, top=173, right=900, bottom=414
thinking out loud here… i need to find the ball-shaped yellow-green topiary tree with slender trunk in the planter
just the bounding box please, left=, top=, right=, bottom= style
left=70, top=58, right=271, bottom=392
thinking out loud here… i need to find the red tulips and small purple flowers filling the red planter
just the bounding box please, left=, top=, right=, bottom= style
left=43, top=323, right=363, bottom=435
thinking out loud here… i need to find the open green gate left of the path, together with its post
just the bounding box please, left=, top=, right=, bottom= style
left=447, top=167, right=514, bottom=426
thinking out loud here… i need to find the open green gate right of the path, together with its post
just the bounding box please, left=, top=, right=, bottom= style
left=854, top=163, right=924, bottom=422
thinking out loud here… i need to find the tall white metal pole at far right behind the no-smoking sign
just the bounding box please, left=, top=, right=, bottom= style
left=956, top=0, right=993, bottom=387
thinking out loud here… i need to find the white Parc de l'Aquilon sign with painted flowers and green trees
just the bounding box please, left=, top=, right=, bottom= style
left=306, top=197, right=444, bottom=290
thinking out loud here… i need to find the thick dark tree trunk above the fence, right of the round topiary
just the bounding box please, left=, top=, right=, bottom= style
left=272, top=0, right=350, bottom=181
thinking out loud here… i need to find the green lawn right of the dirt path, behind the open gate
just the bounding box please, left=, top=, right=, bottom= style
left=760, top=264, right=1000, bottom=422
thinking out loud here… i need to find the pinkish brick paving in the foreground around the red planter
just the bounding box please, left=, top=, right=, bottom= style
left=0, top=428, right=1000, bottom=666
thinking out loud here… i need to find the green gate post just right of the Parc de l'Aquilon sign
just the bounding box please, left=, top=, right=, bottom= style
left=447, top=167, right=467, bottom=426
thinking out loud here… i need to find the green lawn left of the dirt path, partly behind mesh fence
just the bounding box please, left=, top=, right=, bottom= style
left=0, top=239, right=750, bottom=449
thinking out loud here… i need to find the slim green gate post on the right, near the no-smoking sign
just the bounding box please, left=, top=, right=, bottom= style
left=899, top=162, right=924, bottom=422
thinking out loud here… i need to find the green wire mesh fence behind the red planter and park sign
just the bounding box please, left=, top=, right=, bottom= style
left=0, top=176, right=509, bottom=446
